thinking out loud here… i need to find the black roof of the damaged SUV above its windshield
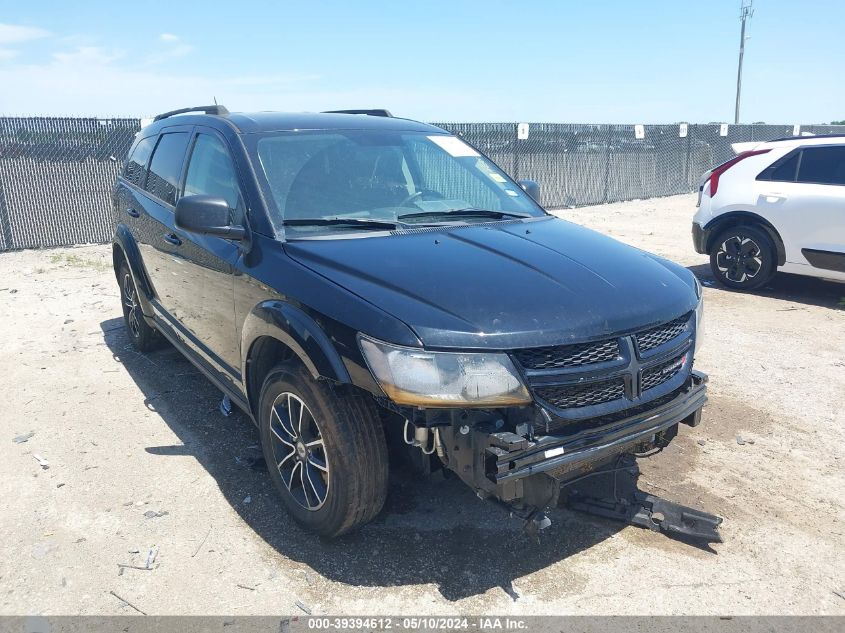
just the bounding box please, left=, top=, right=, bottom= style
left=148, top=112, right=445, bottom=134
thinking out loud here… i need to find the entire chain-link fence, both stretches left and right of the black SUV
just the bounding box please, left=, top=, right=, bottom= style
left=0, top=117, right=845, bottom=251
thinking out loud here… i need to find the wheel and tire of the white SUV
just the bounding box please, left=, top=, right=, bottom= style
left=710, top=226, right=777, bottom=290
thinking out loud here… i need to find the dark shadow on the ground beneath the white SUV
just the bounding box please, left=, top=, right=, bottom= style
left=687, top=264, right=845, bottom=309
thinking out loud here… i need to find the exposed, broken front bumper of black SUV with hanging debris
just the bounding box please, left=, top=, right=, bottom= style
left=438, top=371, right=721, bottom=542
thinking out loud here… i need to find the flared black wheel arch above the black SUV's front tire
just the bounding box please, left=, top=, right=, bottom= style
left=241, top=299, right=352, bottom=383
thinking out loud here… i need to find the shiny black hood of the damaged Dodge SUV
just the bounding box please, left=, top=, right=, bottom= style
left=285, top=218, right=697, bottom=349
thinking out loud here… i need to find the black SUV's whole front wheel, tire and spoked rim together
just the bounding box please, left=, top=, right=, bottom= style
left=258, top=365, right=388, bottom=537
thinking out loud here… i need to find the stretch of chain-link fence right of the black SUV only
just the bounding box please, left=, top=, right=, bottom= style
left=436, top=123, right=845, bottom=208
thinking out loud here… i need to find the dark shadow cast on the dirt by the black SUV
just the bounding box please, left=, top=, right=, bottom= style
left=100, top=318, right=628, bottom=601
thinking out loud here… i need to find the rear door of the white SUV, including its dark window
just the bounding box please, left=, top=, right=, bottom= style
left=758, top=145, right=845, bottom=272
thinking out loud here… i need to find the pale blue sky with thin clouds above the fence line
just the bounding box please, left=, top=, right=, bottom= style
left=0, top=0, right=845, bottom=124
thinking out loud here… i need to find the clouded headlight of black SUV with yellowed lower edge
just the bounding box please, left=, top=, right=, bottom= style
left=360, top=336, right=531, bottom=407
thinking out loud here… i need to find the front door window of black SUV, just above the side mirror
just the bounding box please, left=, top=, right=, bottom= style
left=185, top=134, right=242, bottom=223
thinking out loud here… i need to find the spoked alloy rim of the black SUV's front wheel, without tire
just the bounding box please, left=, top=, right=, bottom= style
left=270, top=391, right=330, bottom=511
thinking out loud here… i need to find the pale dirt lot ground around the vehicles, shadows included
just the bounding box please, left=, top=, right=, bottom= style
left=0, top=196, right=845, bottom=614
